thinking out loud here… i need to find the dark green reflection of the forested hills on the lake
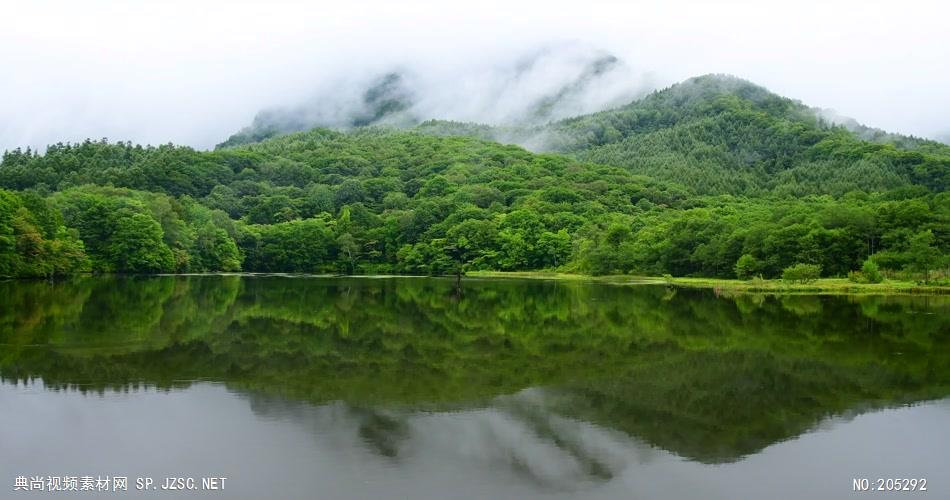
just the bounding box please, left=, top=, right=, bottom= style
left=0, top=276, right=950, bottom=462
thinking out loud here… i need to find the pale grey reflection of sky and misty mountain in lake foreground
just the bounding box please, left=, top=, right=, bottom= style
left=0, top=382, right=950, bottom=500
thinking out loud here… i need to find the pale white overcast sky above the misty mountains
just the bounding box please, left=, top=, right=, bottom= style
left=0, top=0, right=950, bottom=150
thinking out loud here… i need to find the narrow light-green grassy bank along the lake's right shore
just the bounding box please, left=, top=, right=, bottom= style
left=466, top=271, right=950, bottom=295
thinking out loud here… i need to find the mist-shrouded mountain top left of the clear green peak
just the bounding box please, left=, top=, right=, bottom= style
left=218, top=44, right=652, bottom=147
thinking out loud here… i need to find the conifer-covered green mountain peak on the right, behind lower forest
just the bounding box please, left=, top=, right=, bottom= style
left=419, top=75, right=950, bottom=196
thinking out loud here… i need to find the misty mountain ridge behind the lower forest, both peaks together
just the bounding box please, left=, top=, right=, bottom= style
left=219, top=58, right=950, bottom=197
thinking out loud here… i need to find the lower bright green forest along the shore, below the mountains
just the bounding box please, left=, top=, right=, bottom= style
left=0, top=119, right=950, bottom=284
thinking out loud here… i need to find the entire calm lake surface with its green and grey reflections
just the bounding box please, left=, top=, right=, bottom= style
left=0, top=276, right=950, bottom=499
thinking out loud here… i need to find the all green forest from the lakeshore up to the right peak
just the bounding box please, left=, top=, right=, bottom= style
left=0, top=75, right=950, bottom=283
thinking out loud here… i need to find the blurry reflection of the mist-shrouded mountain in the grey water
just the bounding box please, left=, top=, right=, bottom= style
left=242, top=389, right=654, bottom=491
